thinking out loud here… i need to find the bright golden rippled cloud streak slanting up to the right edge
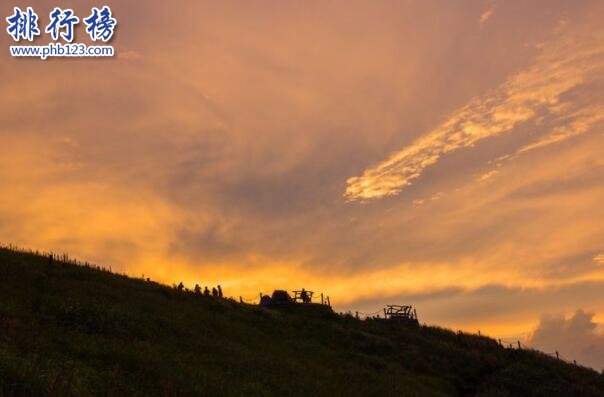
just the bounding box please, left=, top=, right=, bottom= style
left=344, top=32, right=604, bottom=201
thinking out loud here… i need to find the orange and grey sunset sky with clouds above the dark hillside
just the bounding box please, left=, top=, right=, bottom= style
left=0, top=0, right=604, bottom=368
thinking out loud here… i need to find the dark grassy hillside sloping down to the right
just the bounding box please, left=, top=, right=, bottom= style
left=0, top=249, right=604, bottom=397
